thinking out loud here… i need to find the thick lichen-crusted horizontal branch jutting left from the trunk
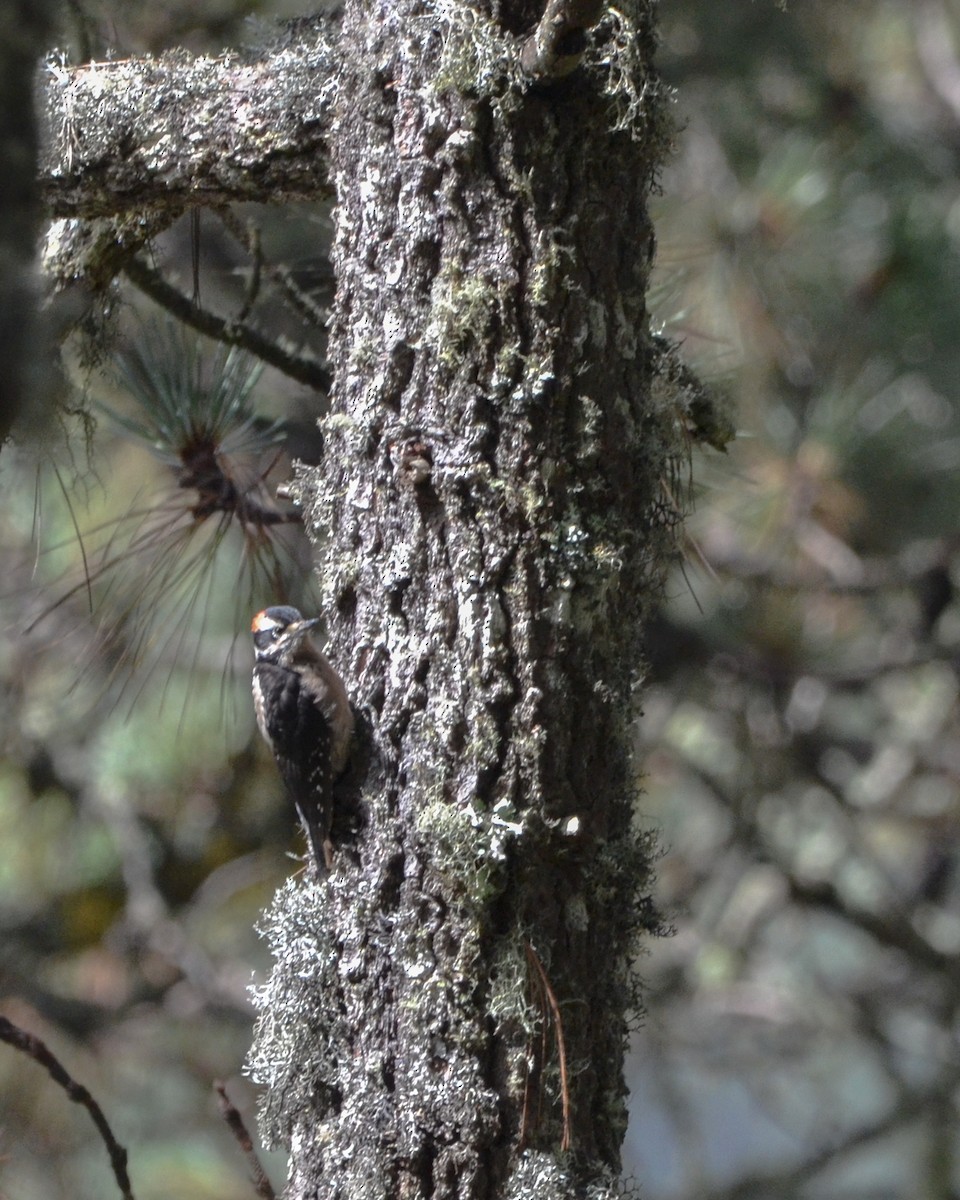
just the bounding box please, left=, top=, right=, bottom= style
left=40, top=18, right=336, bottom=217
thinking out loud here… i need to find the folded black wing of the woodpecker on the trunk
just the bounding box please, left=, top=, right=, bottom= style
left=253, top=662, right=332, bottom=875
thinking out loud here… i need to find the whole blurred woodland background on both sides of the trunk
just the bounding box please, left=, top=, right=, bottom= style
left=0, top=0, right=960, bottom=1200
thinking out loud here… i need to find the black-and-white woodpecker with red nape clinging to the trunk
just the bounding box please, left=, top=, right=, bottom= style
left=251, top=605, right=354, bottom=876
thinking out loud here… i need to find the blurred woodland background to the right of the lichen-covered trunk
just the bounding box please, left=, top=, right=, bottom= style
left=628, top=0, right=960, bottom=1200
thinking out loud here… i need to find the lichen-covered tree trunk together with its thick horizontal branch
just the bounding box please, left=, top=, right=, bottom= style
left=44, top=0, right=697, bottom=1200
